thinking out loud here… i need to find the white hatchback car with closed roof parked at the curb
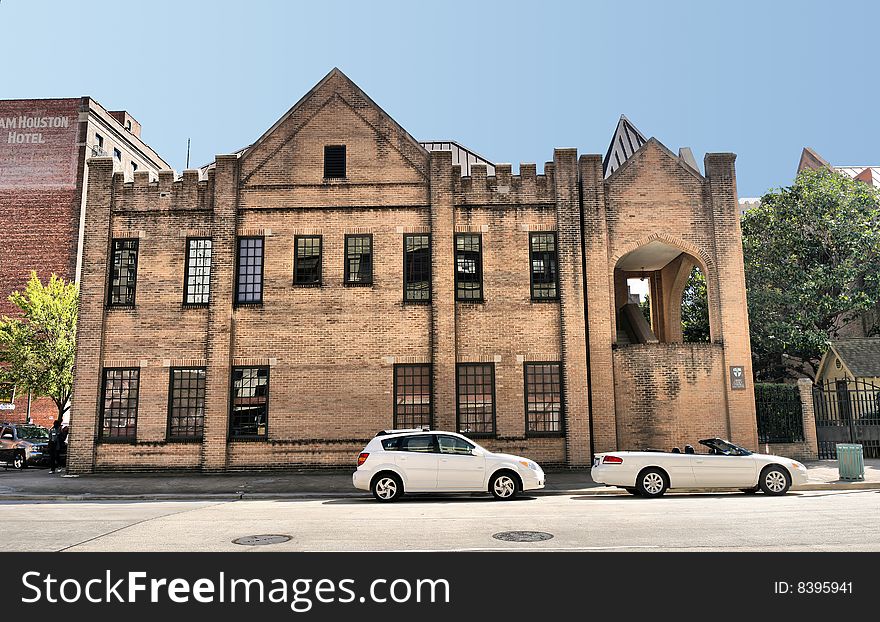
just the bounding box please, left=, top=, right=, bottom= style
left=352, top=429, right=544, bottom=501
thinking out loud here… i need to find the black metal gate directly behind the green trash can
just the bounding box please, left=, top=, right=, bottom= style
left=813, top=380, right=880, bottom=458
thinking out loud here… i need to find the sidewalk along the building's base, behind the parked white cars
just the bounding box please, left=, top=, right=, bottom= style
left=0, top=459, right=880, bottom=502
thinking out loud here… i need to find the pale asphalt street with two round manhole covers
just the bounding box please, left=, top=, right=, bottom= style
left=0, top=490, right=880, bottom=552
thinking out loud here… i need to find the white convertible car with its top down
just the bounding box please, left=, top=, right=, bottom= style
left=591, top=438, right=807, bottom=497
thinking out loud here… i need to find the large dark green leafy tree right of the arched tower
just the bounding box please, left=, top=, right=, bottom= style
left=742, top=170, right=880, bottom=381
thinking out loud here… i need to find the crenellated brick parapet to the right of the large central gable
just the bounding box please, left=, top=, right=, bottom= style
left=452, top=162, right=555, bottom=206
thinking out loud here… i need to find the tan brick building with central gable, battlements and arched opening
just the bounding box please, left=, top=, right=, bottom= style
left=70, top=70, right=757, bottom=472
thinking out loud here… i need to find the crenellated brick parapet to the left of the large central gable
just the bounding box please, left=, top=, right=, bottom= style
left=112, top=169, right=214, bottom=212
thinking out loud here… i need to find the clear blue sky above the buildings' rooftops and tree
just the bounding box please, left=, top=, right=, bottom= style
left=0, top=0, right=880, bottom=197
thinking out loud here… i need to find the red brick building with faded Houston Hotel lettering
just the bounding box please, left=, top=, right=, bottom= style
left=0, top=97, right=170, bottom=425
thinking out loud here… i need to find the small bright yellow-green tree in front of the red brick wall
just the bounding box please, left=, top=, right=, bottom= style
left=0, top=272, right=79, bottom=419
